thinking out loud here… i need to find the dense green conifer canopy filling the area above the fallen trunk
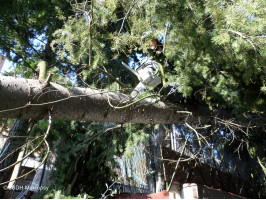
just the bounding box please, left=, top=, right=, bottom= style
left=1, top=0, right=265, bottom=115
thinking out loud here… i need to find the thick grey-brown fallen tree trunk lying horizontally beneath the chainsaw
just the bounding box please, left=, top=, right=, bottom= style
left=0, top=77, right=262, bottom=124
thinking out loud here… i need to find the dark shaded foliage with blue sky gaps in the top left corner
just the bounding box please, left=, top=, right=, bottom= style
left=0, top=0, right=77, bottom=78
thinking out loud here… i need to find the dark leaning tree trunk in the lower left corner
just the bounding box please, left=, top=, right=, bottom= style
left=0, top=119, right=29, bottom=199
